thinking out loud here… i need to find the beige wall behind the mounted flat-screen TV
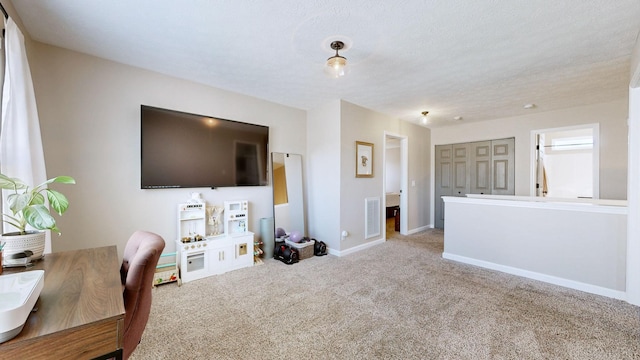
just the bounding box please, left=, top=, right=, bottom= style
left=29, top=42, right=306, bottom=253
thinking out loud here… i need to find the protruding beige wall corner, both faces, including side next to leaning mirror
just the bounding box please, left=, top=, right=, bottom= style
left=307, top=100, right=430, bottom=254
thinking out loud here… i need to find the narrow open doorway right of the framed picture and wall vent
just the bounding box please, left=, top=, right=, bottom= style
left=383, top=133, right=407, bottom=239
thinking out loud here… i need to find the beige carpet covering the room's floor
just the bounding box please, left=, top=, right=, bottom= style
left=132, top=230, right=640, bottom=360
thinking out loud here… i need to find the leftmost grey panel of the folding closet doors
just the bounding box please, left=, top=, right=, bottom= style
left=434, top=145, right=453, bottom=229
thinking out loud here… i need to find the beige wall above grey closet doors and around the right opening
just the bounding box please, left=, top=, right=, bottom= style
left=431, top=99, right=628, bottom=200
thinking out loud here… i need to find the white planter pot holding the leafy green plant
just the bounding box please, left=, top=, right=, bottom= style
left=0, top=231, right=46, bottom=267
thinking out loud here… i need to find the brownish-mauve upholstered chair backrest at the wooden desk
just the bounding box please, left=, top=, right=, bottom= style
left=120, top=231, right=165, bottom=359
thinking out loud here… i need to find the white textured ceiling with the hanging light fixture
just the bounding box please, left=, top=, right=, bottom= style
left=8, top=0, right=640, bottom=127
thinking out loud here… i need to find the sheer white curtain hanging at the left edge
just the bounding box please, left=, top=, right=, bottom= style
left=0, top=18, right=51, bottom=253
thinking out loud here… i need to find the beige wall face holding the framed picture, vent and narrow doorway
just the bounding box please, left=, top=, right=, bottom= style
left=340, top=101, right=430, bottom=250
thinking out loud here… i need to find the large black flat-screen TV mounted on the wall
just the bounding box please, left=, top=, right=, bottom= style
left=140, top=105, right=269, bottom=189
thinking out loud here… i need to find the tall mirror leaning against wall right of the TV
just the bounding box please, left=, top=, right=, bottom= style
left=271, top=153, right=306, bottom=236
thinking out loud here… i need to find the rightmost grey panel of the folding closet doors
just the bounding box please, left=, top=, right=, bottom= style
left=491, top=138, right=516, bottom=195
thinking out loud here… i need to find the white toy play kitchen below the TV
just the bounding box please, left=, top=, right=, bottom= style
left=176, top=197, right=254, bottom=283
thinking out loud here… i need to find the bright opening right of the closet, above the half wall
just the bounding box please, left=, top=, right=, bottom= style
left=531, top=124, right=600, bottom=199
